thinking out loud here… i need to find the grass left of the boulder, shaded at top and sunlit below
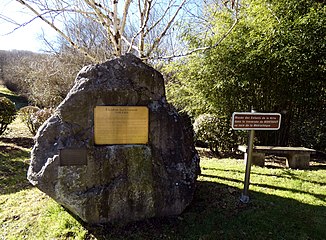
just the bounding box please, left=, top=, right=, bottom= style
left=0, top=142, right=87, bottom=240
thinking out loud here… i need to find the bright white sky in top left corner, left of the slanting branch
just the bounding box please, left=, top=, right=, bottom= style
left=0, top=0, right=55, bottom=52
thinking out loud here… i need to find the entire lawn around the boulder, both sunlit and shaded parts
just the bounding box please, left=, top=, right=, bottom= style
left=0, top=85, right=326, bottom=240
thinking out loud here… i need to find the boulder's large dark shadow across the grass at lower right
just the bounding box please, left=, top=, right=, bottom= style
left=79, top=181, right=326, bottom=240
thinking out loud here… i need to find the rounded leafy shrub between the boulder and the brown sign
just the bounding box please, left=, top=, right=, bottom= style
left=194, top=114, right=243, bottom=153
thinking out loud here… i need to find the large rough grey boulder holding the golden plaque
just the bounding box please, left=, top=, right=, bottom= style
left=27, top=54, right=199, bottom=224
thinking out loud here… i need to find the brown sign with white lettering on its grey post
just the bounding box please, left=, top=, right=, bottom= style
left=232, top=110, right=281, bottom=203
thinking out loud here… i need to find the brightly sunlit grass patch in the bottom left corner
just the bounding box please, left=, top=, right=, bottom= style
left=0, top=188, right=87, bottom=239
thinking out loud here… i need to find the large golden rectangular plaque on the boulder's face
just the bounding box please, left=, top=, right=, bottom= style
left=94, top=106, right=148, bottom=145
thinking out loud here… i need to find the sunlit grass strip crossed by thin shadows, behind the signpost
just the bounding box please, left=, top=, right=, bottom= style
left=200, top=158, right=326, bottom=206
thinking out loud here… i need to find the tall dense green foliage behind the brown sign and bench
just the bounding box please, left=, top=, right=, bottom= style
left=168, top=0, right=326, bottom=151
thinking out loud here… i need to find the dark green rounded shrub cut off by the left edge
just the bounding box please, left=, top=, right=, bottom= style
left=0, top=97, right=16, bottom=135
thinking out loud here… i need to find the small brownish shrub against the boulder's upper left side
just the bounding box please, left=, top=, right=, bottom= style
left=19, top=106, right=53, bottom=135
